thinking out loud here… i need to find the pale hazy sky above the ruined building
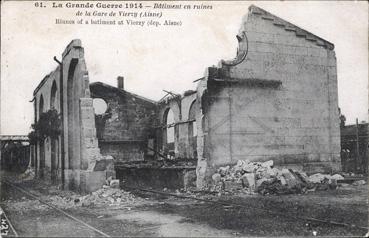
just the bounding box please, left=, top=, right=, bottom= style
left=0, top=1, right=368, bottom=135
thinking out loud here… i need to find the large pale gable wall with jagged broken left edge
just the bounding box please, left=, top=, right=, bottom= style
left=194, top=7, right=340, bottom=186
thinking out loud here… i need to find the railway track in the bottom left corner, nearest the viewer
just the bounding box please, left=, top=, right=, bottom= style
left=1, top=180, right=110, bottom=237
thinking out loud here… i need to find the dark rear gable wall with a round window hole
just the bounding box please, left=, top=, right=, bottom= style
left=90, top=83, right=156, bottom=162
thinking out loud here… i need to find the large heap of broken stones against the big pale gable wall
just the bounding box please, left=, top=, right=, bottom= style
left=212, top=160, right=344, bottom=195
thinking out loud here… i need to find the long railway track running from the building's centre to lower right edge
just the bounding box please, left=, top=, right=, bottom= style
left=124, top=186, right=369, bottom=233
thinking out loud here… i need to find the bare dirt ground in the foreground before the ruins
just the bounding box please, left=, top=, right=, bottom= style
left=0, top=172, right=368, bottom=237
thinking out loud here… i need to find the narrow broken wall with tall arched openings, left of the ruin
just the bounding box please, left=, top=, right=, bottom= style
left=34, top=40, right=112, bottom=192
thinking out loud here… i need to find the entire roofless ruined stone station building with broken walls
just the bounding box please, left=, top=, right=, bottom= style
left=34, top=6, right=340, bottom=190
